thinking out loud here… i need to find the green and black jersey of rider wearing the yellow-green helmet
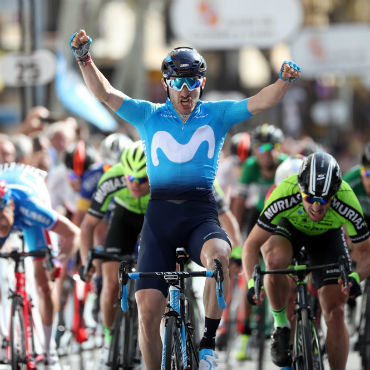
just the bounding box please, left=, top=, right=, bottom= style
left=88, top=163, right=150, bottom=218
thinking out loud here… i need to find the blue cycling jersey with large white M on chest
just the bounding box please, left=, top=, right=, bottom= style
left=116, top=96, right=252, bottom=199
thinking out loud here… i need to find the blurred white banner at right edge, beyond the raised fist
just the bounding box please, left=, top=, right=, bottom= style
left=291, top=23, right=370, bottom=78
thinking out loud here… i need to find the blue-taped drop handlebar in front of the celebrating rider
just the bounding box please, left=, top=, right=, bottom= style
left=118, top=259, right=226, bottom=311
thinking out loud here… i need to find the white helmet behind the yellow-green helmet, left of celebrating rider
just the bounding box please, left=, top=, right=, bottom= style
left=100, top=133, right=132, bottom=166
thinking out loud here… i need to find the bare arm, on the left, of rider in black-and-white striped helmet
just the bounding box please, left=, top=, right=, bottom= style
left=242, top=224, right=271, bottom=281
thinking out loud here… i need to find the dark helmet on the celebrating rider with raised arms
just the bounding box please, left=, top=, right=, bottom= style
left=161, top=46, right=207, bottom=79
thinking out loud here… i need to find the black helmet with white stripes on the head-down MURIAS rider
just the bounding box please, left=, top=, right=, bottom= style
left=298, top=152, right=342, bottom=198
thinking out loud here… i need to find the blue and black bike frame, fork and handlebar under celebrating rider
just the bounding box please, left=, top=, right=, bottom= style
left=119, top=254, right=226, bottom=370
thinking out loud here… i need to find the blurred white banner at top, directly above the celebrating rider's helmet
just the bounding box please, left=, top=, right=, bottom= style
left=170, top=0, right=303, bottom=50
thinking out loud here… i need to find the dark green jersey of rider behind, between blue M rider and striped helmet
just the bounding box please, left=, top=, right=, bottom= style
left=238, top=153, right=288, bottom=211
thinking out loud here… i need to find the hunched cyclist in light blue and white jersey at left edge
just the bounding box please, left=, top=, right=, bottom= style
left=0, top=163, right=80, bottom=370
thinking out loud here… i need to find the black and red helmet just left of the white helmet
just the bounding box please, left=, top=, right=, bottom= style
left=64, top=140, right=97, bottom=176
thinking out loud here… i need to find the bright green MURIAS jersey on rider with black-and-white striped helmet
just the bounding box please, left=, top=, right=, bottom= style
left=257, top=174, right=369, bottom=243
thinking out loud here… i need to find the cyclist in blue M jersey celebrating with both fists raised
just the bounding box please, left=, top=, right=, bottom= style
left=70, top=30, right=300, bottom=370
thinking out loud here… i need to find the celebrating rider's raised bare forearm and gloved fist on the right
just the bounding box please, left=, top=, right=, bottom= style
left=248, top=62, right=301, bottom=114
